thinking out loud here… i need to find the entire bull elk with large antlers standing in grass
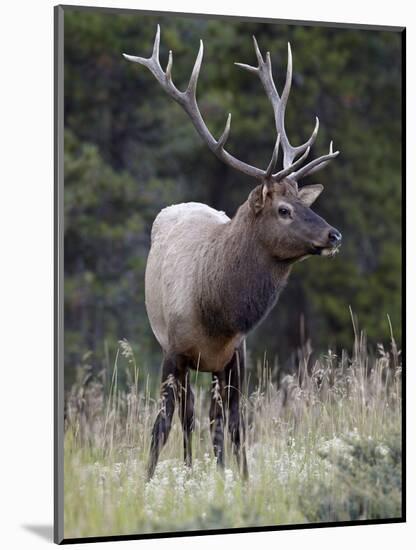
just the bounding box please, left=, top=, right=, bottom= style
left=123, top=26, right=341, bottom=479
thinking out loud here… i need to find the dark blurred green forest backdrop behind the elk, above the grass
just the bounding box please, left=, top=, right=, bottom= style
left=64, top=8, right=402, bottom=386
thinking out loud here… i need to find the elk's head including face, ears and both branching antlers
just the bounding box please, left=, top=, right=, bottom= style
left=123, top=25, right=342, bottom=261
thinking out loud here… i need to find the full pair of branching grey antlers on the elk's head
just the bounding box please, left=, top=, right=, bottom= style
left=123, top=25, right=338, bottom=183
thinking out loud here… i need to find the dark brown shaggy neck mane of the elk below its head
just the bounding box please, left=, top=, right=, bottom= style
left=198, top=202, right=291, bottom=338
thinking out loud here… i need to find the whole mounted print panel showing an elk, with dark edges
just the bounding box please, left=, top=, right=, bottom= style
left=55, top=6, right=405, bottom=543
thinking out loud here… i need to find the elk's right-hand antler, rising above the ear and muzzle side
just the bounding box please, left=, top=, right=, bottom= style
left=235, top=36, right=339, bottom=181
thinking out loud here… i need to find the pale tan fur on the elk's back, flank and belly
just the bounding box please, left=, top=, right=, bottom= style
left=146, top=202, right=244, bottom=372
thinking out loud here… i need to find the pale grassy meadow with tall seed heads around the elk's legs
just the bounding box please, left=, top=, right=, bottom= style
left=64, top=322, right=402, bottom=538
